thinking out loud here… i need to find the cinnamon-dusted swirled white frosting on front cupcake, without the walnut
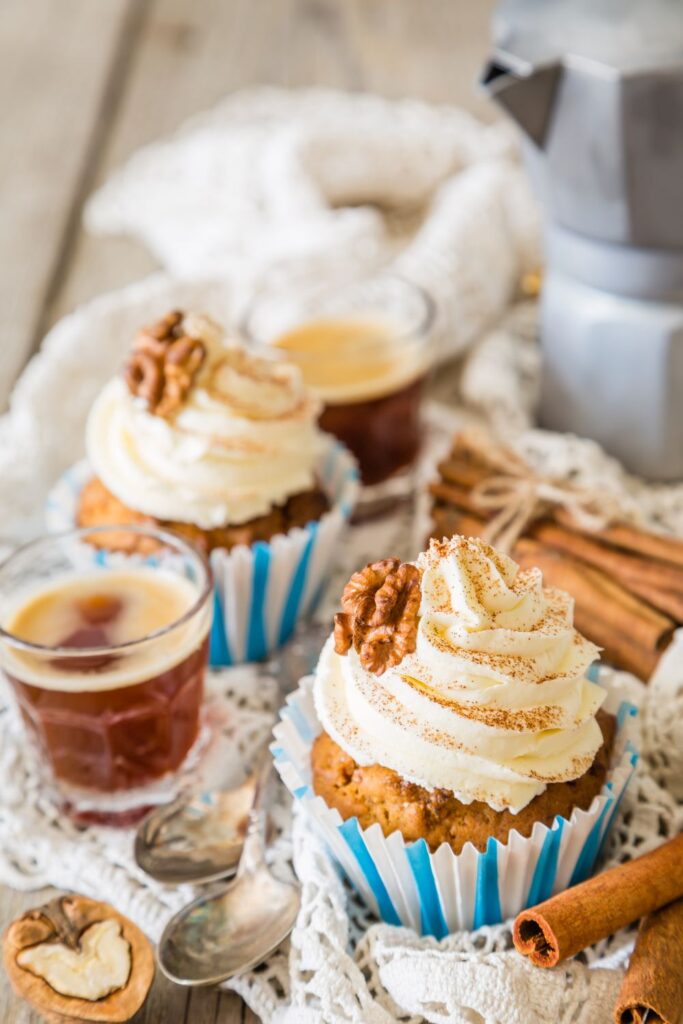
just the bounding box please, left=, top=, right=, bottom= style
left=314, top=537, right=604, bottom=813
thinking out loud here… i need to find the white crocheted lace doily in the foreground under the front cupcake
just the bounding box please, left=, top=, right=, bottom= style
left=0, top=622, right=683, bottom=1024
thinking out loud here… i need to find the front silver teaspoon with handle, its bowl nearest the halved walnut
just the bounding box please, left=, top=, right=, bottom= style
left=157, top=759, right=301, bottom=985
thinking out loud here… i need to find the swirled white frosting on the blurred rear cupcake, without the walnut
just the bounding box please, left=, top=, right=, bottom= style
left=86, top=313, right=323, bottom=529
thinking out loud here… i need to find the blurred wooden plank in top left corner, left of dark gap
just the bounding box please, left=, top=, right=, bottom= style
left=0, top=0, right=139, bottom=408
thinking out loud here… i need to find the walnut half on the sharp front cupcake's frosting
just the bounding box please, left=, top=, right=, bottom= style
left=335, top=558, right=420, bottom=676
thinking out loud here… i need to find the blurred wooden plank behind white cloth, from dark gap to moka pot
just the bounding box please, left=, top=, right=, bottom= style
left=49, top=0, right=495, bottom=322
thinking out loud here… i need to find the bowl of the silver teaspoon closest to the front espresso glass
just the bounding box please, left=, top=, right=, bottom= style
left=134, top=775, right=256, bottom=885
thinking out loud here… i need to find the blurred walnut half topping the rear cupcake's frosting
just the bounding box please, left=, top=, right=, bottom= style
left=124, top=310, right=206, bottom=416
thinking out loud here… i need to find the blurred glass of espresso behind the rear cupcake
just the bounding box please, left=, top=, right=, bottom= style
left=243, top=273, right=434, bottom=502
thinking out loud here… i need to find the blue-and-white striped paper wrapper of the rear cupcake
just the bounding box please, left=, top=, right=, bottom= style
left=45, top=438, right=358, bottom=667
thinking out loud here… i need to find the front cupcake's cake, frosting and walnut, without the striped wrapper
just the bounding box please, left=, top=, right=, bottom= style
left=312, top=537, right=614, bottom=853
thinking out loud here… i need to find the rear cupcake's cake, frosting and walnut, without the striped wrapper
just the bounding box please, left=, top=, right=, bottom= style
left=77, top=311, right=330, bottom=552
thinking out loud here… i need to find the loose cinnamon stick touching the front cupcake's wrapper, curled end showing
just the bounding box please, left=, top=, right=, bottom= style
left=512, top=835, right=683, bottom=968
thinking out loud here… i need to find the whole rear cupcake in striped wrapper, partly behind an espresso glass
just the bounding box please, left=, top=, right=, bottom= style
left=47, top=311, right=357, bottom=664
